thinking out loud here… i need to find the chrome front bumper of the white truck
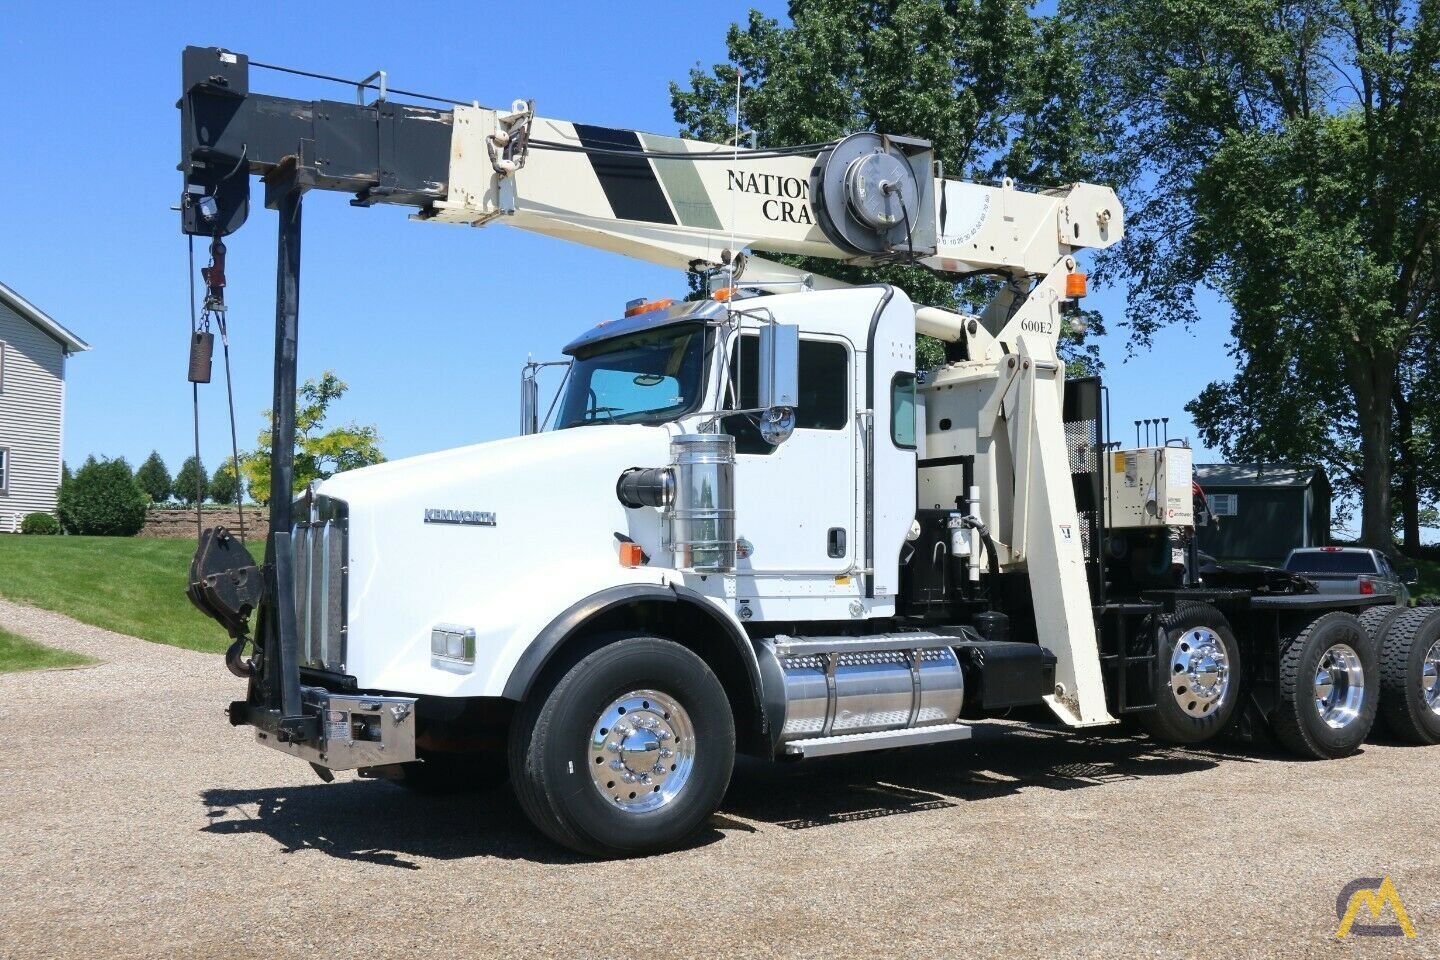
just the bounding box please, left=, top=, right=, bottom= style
left=230, top=687, right=415, bottom=770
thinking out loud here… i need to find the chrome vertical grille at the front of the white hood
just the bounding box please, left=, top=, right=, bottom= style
left=291, top=497, right=348, bottom=674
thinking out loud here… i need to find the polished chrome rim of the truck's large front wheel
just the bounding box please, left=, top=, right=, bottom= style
left=589, top=689, right=696, bottom=813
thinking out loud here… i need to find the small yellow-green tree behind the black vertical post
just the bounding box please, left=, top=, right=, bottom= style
left=240, top=370, right=384, bottom=504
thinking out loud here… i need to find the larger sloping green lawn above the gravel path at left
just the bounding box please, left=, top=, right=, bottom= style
left=0, top=535, right=229, bottom=652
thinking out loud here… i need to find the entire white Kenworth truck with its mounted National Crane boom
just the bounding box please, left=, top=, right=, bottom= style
left=180, top=47, right=1440, bottom=855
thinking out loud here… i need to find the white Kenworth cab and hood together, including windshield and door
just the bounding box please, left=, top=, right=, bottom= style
left=298, top=288, right=916, bottom=698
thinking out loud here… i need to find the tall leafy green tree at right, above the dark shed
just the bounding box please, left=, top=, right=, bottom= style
left=1082, top=0, right=1440, bottom=547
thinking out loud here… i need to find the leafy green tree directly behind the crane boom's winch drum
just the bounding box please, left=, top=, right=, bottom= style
left=670, top=0, right=1109, bottom=368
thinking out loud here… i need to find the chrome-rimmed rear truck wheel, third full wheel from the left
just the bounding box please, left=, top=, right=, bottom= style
left=1272, top=612, right=1380, bottom=760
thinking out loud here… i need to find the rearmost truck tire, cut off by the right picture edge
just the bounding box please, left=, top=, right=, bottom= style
left=1380, top=607, right=1440, bottom=744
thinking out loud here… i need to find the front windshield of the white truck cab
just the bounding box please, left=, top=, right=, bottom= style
left=556, top=324, right=706, bottom=430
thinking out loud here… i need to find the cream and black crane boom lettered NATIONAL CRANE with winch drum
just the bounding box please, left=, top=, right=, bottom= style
left=180, top=47, right=1123, bottom=276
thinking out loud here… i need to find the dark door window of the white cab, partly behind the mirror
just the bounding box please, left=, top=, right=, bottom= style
left=721, top=334, right=850, bottom=453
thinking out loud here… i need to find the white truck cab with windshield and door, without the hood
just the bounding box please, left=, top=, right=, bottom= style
left=556, top=286, right=916, bottom=622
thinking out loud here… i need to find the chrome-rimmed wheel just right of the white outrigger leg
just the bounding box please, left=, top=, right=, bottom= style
left=1140, top=603, right=1244, bottom=744
